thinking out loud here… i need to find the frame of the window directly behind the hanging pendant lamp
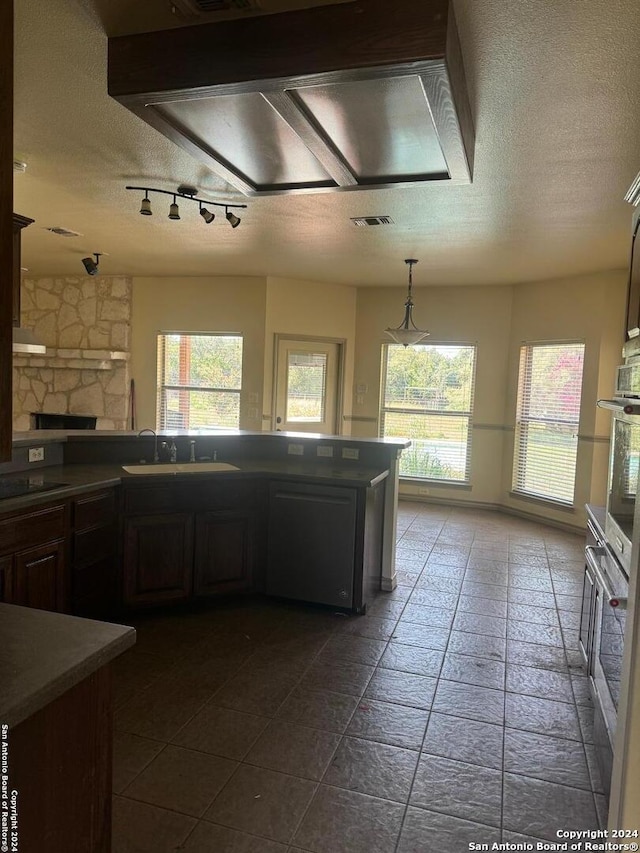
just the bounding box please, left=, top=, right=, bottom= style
left=378, top=341, right=478, bottom=488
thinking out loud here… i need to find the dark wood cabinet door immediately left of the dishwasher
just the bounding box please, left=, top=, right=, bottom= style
left=194, top=510, right=255, bottom=595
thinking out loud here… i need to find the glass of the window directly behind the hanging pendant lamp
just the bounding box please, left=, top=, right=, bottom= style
left=380, top=344, right=476, bottom=482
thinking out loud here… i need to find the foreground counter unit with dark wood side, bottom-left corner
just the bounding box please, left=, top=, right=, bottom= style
left=0, top=604, right=135, bottom=853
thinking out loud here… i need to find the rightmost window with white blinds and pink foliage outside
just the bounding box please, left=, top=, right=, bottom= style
left=513, top=343, right=584, bottom=504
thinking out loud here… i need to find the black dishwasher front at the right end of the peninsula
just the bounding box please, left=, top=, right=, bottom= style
left=266, top=482, right=357, bottom=607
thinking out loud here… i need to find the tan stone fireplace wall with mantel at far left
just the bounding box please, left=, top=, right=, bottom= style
left=13, top=276, right=132, bottom=431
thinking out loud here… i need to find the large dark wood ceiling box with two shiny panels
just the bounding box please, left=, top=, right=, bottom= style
left=108, top=0, right=475, bottom=196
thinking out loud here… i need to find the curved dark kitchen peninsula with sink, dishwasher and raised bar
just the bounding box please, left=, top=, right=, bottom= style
left=0, top=430, right=409, bottom=617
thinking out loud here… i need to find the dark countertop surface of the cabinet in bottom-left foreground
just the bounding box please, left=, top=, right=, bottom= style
left=0, top=604, right=136, bottom=728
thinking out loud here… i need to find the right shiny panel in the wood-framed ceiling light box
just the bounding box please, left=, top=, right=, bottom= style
left=294, top=76, right=449, bottom=184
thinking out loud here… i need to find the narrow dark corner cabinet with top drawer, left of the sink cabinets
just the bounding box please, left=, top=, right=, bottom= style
left=71, top=489, right=118, bottom=619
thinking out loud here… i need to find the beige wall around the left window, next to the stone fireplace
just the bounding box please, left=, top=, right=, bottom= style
left=131, top=276, right=266, bottom=430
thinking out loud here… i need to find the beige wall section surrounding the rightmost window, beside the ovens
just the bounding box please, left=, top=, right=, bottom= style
left=503, top=270, right=626, bottom=526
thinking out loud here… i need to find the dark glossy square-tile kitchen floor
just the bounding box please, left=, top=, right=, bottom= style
left=113, top=503, right=606, bottom=853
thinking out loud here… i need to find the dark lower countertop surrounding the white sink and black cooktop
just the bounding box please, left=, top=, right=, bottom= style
left=0, top=458, right=389, bottom=513
